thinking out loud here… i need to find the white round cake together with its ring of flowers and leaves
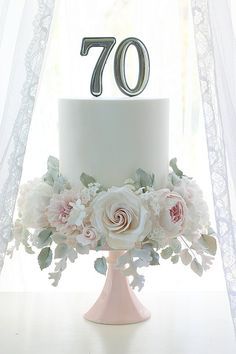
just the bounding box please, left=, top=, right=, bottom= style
left=10, top=98, right=217, bottom=292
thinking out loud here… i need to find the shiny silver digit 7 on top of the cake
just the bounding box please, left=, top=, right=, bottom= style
left=80, top=37, right=116, bottom=96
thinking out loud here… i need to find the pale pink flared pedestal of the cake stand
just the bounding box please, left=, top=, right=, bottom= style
left=84, top=251, right=150, bottom=324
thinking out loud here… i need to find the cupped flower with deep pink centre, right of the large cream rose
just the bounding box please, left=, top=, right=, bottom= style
left=148, top=189, right=188, bottom=238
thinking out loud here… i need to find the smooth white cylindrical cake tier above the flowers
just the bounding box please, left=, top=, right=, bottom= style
left=59, top=98, right=169, bottom=188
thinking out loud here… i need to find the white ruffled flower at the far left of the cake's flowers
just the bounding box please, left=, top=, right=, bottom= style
left=18, top=178, right=53, bottom=228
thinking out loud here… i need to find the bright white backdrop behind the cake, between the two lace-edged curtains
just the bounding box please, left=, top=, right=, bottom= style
left=0, top=0, right=228, bottom=296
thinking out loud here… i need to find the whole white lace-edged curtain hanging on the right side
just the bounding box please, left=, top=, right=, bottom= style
left=192, top=0, right=236, bottom=328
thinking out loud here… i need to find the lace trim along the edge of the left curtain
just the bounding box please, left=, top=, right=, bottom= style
left=0, top=0, right=55, bottom=271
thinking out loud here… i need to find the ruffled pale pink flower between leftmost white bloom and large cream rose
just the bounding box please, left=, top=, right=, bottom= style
left=48, top=190, right=85, bottom=234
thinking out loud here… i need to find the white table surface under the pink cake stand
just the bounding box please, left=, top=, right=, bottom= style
left=0, top=292, right=236, bottom=354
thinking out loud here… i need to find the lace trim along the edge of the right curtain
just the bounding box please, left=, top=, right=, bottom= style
left=192, top=0, right=236, bottom=329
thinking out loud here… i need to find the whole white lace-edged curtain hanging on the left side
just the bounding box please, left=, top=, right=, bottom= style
left=0, top=0, right=54, bottom=271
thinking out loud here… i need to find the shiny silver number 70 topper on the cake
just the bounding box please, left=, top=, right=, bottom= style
left=80, top=37, right=150, bottom=96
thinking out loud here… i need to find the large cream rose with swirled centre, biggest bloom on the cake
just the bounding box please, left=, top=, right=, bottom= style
left=91, top=187, right=151, bottom=249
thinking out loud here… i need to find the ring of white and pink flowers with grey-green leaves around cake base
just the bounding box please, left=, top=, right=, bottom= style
left=8, top=156, right=216, bottom=290
